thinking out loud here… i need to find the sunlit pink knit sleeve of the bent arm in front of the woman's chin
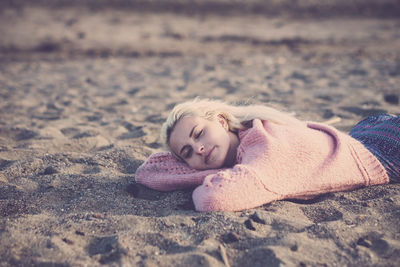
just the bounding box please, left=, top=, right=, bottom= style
left=193, top=119, right=282, bottom=211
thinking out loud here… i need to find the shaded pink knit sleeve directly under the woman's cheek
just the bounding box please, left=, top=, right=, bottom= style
left=135, top=152, right=219, bottom=191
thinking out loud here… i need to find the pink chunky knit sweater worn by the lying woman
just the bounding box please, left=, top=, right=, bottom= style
left=136, top=119, right=389, bottom=211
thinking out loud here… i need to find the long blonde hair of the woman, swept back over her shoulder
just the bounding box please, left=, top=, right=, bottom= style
left=161, top=98, right=295, bottom=148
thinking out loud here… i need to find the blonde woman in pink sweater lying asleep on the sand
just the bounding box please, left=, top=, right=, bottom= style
left=136, top=99, right=400, bottom=211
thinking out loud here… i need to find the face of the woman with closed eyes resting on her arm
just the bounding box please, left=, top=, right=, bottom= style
left=169, top=116, right=236, bottom=170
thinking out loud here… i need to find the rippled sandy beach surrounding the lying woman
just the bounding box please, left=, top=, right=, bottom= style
left=0, top=0, right=400, bottom=267
